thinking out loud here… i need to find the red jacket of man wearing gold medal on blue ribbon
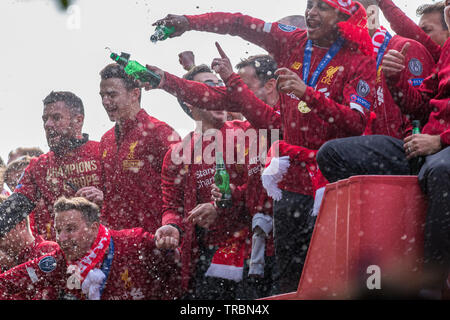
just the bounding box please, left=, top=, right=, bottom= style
left=183, top=13, right=376, bottom=195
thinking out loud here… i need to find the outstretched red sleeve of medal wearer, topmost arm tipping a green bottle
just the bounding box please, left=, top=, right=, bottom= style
left=186, top=12, right=296, bottom=61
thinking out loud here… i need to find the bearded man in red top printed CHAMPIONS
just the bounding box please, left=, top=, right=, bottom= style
left=0, top=92, right=102, bottom=240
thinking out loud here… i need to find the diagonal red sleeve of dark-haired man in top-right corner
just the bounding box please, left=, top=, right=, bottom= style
left=379, top=0, right=442, bottom=62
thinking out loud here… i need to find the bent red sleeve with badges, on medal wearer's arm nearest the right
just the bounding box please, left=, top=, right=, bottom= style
left=301, top=57, right=376, bottom=136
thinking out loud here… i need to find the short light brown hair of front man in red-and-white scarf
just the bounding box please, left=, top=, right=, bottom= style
left=53, top=197, right=100, bottom=225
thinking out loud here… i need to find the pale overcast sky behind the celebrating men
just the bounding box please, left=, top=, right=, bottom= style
left=0, top=0, right=433, bottom=162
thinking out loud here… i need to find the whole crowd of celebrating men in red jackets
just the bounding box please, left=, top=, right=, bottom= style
left=0, top=0, right=450, bottom=300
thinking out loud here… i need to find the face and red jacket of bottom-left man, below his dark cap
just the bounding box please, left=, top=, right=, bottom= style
left=0, top=217, right=66, bottom=300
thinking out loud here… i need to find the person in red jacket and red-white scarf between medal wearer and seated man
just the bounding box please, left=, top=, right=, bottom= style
left=360, top=0, right=434, bottom=139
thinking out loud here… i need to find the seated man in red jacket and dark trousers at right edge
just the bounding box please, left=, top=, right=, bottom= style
left=317, top=10, right=450, bottom=294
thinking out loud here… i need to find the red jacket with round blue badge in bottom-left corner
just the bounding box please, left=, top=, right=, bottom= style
left=0, top=236, right=66, bottom=300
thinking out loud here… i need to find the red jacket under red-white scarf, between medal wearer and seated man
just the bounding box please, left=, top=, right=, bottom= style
left=371, top=35, right=435, bottom=139
